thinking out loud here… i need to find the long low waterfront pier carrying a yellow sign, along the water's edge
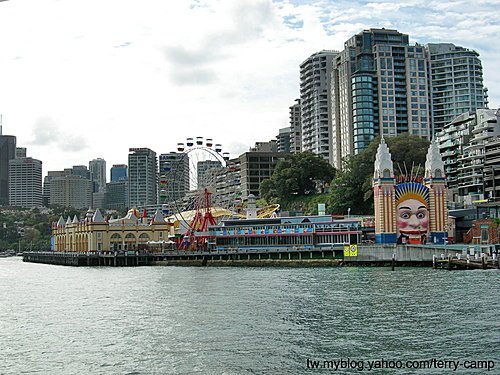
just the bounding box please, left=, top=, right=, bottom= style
left=23, top=245, right=498, bottom=269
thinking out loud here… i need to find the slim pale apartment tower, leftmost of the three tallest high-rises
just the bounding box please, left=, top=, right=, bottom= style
left=300, top=50, right=338, bottom=163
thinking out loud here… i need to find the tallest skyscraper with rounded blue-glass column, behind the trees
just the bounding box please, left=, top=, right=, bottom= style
left=332, top=29, right=430, bottom=168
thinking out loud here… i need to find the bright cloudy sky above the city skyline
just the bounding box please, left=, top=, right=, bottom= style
left=0, top=0, right=500, bottom=175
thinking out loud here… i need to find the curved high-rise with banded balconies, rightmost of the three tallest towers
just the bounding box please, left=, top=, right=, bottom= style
left=426, top=43, right=488, bottom=134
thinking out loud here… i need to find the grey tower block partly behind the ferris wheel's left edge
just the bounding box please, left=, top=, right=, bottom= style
left=159, top=152, right=190, bottom=204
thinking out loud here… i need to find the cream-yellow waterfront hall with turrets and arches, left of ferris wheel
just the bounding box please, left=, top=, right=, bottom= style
left=52, top=209, right=173, bottom=253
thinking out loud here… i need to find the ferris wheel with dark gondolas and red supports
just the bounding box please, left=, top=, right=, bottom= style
left=160, top=137, right=239, bottom=233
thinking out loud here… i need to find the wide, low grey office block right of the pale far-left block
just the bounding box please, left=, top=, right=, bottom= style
left=49, top=175, right=93, bottom=209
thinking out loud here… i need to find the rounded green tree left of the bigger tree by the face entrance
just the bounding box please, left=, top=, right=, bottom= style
left=260, top=152, right=335, bottom=202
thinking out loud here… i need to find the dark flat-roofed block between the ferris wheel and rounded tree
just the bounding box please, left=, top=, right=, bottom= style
left=237, top=151, right=286, bottom=199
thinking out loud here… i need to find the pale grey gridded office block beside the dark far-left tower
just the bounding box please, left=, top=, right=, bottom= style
left=9, top=157, right=42, bottom=208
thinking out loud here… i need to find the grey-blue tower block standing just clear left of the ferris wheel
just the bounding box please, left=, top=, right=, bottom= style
left=128, top=148, right=158, bottom=207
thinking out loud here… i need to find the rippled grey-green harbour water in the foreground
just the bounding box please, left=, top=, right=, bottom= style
left=0, top=257, right=500, bottom=374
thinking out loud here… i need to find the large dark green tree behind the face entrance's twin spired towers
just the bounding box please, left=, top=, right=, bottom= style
left=330, top=134, right=429, bottom=214
